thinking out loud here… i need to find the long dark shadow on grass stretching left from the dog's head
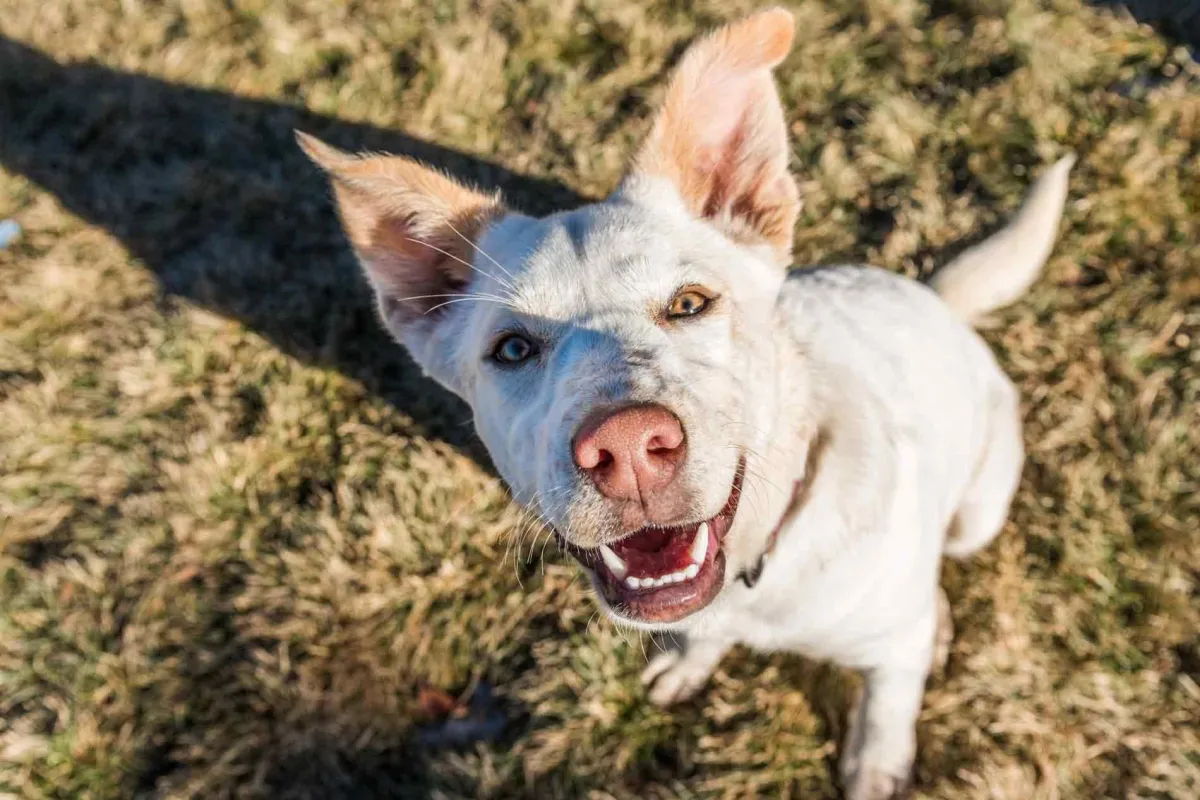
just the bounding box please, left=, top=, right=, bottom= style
left=0, top=37, right=582, bottom=470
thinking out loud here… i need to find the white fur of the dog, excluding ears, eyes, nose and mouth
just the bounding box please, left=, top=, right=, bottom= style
left=374, top=160, right=1069, bottom=798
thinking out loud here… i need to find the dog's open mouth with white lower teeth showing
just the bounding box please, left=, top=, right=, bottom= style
left=568, top=458, right=745, bottom=622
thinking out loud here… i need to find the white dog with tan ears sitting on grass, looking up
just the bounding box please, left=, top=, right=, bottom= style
left=298, top=10, right=1073, bottom=800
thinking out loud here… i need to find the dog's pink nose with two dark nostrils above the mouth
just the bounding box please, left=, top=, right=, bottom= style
left=575, top=405, right=686, bottom=501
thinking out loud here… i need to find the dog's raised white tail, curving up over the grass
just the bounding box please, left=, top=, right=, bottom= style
left=930, top=155, right=1075, bottom=321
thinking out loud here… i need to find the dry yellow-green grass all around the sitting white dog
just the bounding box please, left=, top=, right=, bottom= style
left=0, top=0, right=1200, bottom=800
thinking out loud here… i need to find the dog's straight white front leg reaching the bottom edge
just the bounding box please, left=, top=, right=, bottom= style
left=841, top=609, right=937, bottom=800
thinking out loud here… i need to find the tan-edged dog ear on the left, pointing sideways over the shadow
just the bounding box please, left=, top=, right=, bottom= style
left=296, top=131, right=504, bottom=344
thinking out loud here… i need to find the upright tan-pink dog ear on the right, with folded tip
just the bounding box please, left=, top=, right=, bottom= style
left=619, top=8, right=800, bottom=265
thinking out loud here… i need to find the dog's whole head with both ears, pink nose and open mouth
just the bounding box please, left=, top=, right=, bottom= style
left=301, top=11, right=799, bottom=626
